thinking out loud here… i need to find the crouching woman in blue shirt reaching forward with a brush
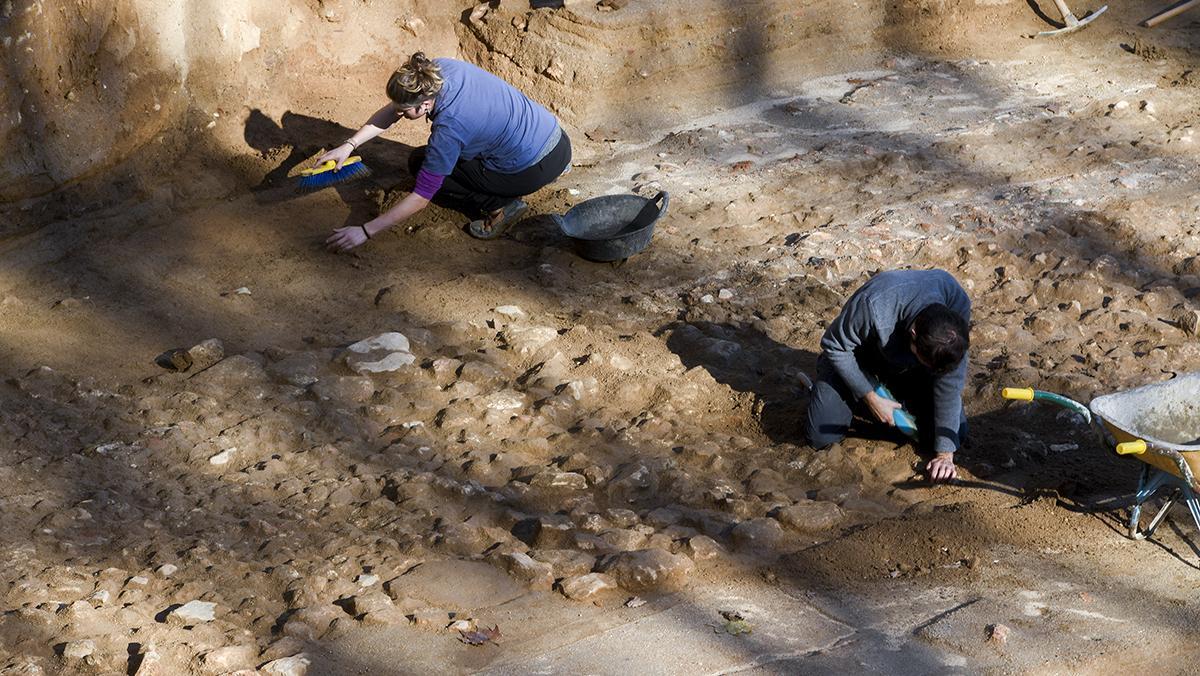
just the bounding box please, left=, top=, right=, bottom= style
left=318, top=52, right=571, bottom=251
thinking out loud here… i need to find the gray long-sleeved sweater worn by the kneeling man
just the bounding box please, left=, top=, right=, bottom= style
left=821, top=270, right=971, bottom=453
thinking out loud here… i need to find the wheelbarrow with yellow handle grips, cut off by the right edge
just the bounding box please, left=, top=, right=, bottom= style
left=1001, top=372, right=1200, bottom=540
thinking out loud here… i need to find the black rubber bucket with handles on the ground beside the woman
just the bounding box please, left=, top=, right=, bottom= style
left=552, top=191, right=671, bottom=263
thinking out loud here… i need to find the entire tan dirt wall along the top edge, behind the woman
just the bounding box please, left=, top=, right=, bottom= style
left=0, top=0, right=1056, bottom=209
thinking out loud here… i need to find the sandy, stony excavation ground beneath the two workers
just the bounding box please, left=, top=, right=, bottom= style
left=0, top=0, right=1200, bottom=674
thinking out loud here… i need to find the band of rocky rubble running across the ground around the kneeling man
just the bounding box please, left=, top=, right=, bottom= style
left=7, top=204, right=1200, bottom=672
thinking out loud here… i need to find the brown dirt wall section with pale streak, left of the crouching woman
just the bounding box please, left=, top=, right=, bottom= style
left=0, top=0, right=457, bottom=203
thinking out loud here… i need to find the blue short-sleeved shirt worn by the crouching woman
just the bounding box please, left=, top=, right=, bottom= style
left=421, top=59, right=558, bottom=177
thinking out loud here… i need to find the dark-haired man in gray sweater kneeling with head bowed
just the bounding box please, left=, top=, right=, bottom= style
left=806, top=270, right=971, bottom=481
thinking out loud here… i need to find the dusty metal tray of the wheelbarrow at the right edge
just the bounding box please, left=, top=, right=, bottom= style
left=1088, top=372, right=1200, bottom=477
